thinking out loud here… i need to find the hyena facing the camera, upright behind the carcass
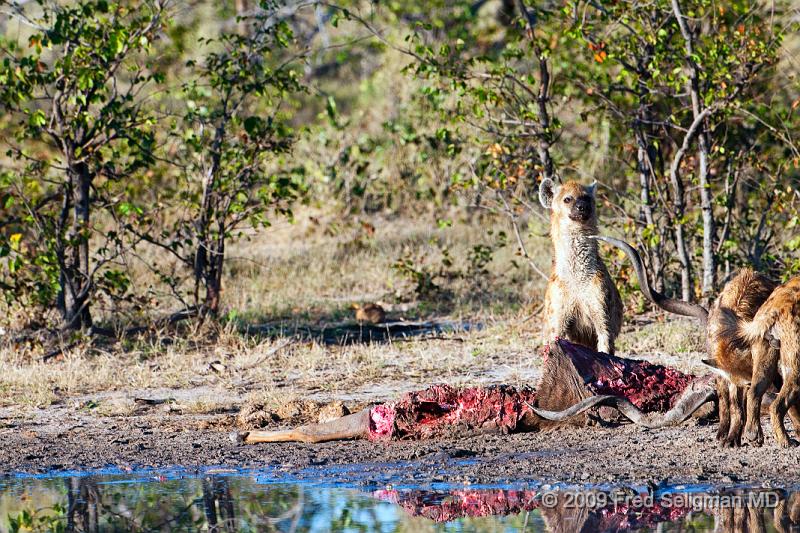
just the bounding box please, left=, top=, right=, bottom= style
left=539, top=179, right=622, bottom=354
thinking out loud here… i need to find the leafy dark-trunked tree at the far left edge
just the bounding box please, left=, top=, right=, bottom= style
left=0, top=0, right=164, bottom=330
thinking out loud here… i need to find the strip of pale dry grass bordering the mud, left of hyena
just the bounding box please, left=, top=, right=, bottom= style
left=0, top=326, right=538, bottom=408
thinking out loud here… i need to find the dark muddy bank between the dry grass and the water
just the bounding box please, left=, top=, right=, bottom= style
left=0, top=390, right=800, bottom=486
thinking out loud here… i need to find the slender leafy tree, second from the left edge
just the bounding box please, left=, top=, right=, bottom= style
left=140, top=2, right=305, bottom=317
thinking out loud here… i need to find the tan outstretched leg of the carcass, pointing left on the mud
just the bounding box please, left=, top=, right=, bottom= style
left=230, top=409, right=369, bottom=444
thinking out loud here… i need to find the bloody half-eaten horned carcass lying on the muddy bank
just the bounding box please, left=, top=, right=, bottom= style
left=233, top=340, right=715, bottom=443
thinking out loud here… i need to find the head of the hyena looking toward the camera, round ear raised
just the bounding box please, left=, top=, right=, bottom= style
left=539, top=178, right=597, bottom=227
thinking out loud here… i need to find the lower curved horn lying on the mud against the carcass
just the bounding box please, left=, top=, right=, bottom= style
left=532, top=385, right=716, bottom=429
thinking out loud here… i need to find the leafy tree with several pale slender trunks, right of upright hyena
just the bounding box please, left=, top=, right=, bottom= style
left=570, top=0, right=783, bottom=301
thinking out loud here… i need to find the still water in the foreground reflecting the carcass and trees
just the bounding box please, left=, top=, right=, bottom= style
left=0, top=472, right=800, bottom=532
